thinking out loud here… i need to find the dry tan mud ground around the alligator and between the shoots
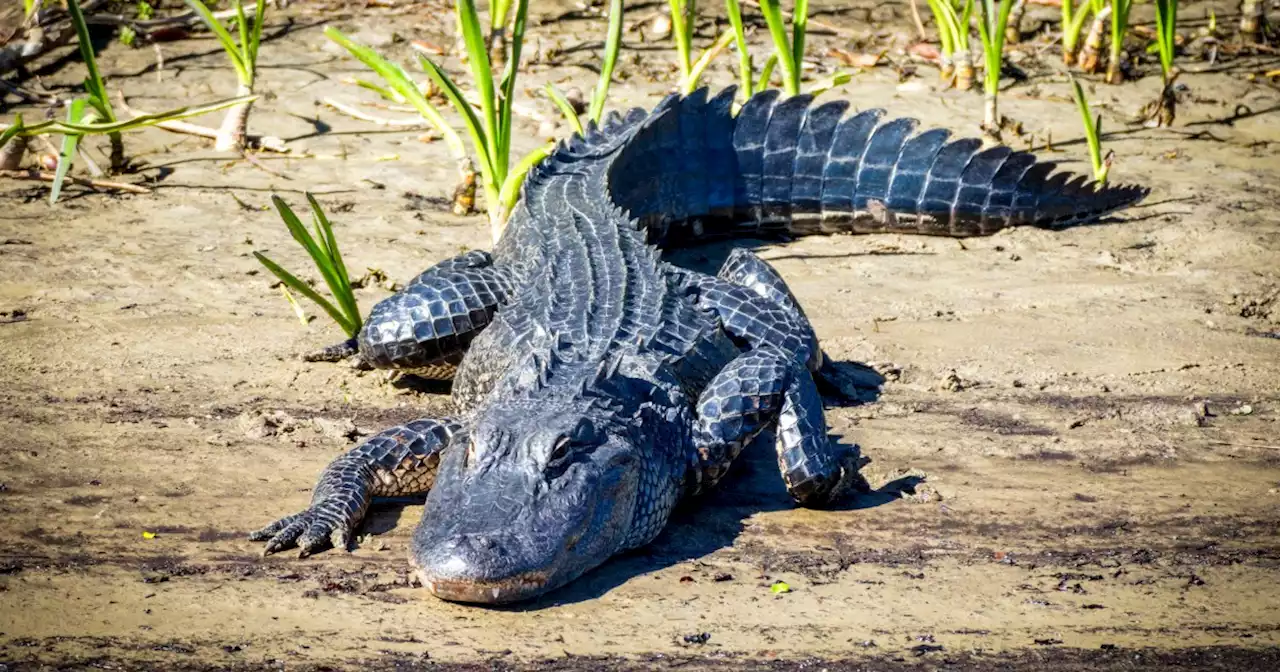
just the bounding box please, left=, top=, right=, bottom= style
left=0, top=3, right=1280, bottom=671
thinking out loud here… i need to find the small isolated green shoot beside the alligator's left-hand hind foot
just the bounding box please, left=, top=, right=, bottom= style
left=253, top=193, right=364, bottom=338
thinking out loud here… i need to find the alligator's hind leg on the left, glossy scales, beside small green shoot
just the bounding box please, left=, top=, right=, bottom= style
left=317, top=251, right=512, bottom=380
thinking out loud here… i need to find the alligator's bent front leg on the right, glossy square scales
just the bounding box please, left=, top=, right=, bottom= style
left=694, top=346, right=869, bottom=506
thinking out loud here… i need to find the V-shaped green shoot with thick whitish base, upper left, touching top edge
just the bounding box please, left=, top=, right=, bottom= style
left=186, top=0, right=266, bottom=154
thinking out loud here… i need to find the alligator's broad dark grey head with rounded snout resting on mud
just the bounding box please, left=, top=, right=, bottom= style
left=410, top=398, right=643, bottom=604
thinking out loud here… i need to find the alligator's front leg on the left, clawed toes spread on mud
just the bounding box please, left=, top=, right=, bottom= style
left=250, top=419, right=462, bottom=557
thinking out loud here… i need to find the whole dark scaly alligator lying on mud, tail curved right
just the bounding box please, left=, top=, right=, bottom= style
left=251, top=88, right=1147, bottom=604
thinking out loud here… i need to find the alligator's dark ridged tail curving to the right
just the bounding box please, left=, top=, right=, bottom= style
left=601, top=87, right=1148, bottom=244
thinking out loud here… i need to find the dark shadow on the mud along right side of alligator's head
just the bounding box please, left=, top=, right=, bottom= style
left=490, top=432, right=922, bottom=612
